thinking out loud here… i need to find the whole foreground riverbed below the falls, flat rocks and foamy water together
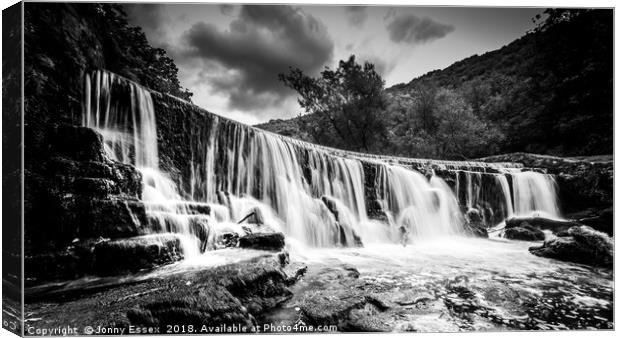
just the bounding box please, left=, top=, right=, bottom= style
left=25, top=237, right=614, bottom=333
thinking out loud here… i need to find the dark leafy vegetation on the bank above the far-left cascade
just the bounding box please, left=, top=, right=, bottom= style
left=24, top=3, right=192, bottom=133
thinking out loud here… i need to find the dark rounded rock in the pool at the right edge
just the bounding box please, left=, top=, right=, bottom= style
left=529, top=226, right=614, bottom=268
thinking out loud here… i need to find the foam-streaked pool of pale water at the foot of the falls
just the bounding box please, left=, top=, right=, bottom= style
left=265, top=237, right=613, bottom=331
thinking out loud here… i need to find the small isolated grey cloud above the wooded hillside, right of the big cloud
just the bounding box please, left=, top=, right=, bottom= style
left=387, top=13, right=454, bottom=45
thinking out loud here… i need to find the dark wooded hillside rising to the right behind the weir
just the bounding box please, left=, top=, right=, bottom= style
left=259, top=9, right=613, bottom=159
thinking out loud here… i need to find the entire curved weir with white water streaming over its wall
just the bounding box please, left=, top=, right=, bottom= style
left=83, top=71, right=560, bottom=256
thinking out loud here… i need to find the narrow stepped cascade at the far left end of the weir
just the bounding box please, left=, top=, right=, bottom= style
left=82, top=71, right=198, bottom=256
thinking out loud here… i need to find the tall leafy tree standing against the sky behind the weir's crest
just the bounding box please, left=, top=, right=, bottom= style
left=279, top=55, right=387, bottom=151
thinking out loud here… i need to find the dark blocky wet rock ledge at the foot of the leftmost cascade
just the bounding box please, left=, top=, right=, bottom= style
left=94, top=234, right=183, bottom=275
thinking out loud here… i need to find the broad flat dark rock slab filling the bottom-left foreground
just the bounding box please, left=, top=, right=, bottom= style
left=26, top=254, right=297, bottom=335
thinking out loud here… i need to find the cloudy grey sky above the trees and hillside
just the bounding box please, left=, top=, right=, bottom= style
left=125, top=3, right=543, bottom=125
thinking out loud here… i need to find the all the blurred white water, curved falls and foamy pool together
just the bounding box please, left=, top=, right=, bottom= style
left=74, top=71, right=613, bottom=331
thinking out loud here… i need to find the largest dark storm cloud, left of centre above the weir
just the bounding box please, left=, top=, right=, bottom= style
left=181, top=5, right=334, bottom=110
